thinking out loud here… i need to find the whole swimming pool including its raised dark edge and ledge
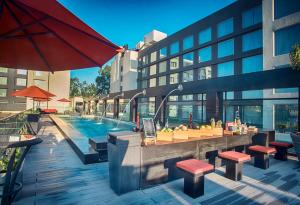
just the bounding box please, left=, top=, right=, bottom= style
left=55, top=115, right=135, bottom=164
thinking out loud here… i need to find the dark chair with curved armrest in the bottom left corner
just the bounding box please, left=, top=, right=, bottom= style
left=0, top=138, right=42, bottom=205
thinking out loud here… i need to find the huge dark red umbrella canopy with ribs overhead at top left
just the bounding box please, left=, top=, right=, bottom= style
left=0, top=0, right=120, bottom=72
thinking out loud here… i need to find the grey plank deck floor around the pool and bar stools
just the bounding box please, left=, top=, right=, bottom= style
left=14, top=119, right=300, bottom=205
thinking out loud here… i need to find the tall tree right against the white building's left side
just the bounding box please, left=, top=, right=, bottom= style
left=95, top=65, right=111, bottom=95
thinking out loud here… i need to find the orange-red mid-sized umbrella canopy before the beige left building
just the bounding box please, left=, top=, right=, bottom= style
left=11, top=86, right=55, bottom=99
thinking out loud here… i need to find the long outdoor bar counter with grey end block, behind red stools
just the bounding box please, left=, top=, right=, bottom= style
left=108, top=131, right=275, bottom=194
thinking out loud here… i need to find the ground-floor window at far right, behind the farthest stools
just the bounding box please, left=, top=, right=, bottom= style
left=274, top=104, right=299, bottom=133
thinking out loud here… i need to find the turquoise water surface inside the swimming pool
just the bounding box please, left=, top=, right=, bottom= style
left=61, top=117, right=134, bottom=138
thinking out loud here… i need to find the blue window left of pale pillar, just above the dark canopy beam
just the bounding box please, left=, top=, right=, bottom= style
left=242, top=55, right=263, bottom=73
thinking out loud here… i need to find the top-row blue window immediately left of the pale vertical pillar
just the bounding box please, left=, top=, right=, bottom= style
left=242, top=5, right=262, bottom=28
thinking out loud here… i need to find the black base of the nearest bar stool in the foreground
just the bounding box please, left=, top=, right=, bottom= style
left=184, top=173, right=204, bottom=198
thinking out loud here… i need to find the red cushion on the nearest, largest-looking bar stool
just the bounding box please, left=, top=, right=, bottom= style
left=176, top=159, right=214, bottom=174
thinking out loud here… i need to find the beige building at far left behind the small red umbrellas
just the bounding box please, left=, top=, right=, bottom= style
left=0, top=67, right=70, bottom=112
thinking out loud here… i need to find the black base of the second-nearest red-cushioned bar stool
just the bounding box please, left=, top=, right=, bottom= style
left=225, top=160, right=243, bottom=181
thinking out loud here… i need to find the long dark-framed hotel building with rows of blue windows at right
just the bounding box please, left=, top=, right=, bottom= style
left=109, top=0, right=300, bottom=139
